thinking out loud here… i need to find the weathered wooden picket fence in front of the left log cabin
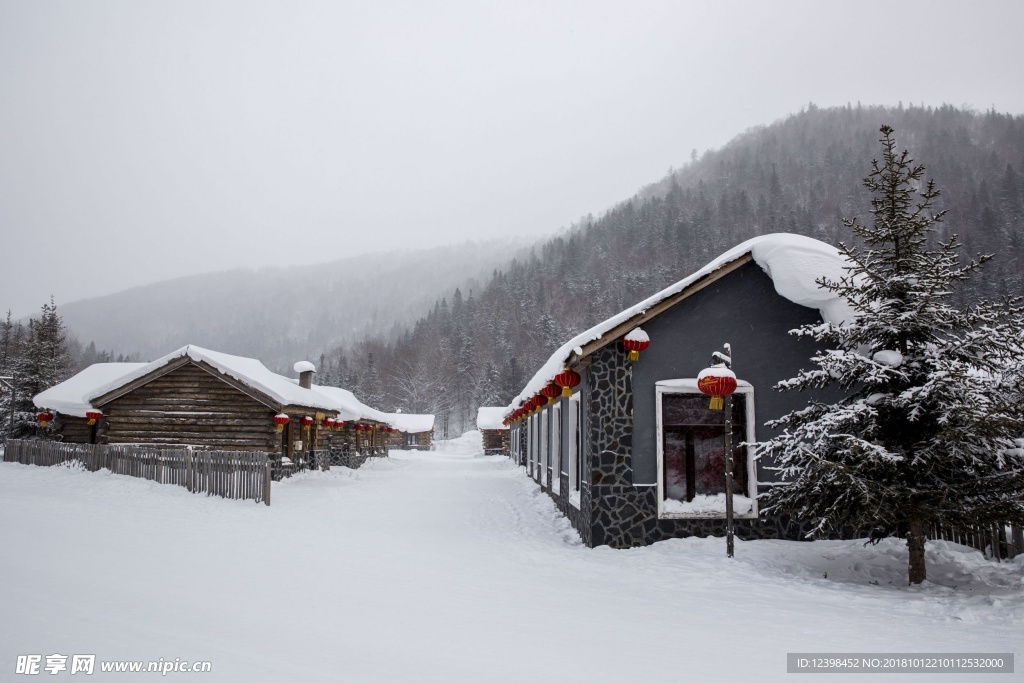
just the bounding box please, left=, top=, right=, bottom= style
left=3, top=439, right=270, bottom=505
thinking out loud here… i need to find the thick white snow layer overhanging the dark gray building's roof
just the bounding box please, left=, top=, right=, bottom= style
left=505, top=232, right=854, bottom=415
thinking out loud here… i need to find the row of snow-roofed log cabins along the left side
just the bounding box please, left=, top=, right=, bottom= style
left=34, top=345, right=434, bottom=462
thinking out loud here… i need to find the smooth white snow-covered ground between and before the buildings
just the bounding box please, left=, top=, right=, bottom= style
left=0, top=433, right=1024, bottom=683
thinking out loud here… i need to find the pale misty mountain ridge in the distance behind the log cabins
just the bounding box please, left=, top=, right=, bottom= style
left=60, top=239, right=523, bottom=372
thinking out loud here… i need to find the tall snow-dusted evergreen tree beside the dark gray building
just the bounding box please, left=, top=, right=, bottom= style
left=758, top=126, right=1024, bottom=584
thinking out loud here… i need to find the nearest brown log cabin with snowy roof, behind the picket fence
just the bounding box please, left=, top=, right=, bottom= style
left=34, top=345, right=339, bottom=459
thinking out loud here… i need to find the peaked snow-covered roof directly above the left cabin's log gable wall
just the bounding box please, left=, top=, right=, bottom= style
left=85, top=344, right=337, bottom=411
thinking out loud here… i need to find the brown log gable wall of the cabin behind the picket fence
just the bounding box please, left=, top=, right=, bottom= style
left=100, top=364, right=281, bottom=452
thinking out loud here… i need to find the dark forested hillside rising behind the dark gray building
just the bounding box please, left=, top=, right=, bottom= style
left=319, top=105, right=1024, bottom=433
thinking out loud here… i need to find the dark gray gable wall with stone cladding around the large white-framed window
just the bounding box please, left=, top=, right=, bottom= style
left=521, top=262, right=843, bottom=548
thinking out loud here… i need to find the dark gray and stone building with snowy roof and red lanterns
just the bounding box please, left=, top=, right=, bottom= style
left=478, top=234, right=852, bottom=548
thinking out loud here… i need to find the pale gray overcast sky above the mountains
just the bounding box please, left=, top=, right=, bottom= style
left=0, top=0, right=1024, bottom=315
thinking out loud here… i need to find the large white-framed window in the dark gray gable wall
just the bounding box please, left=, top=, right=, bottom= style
left=656, top=380, right=757, bottom=517
